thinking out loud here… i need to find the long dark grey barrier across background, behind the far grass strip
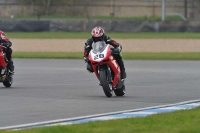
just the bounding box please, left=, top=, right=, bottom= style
left=0, top=19, right=200, bottom=33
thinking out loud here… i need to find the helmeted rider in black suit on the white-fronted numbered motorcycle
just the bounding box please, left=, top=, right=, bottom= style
left=83, top=26, right=126, bottom=79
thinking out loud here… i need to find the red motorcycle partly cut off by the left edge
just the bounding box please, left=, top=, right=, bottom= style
left=0, top=45, right=13, bottom=87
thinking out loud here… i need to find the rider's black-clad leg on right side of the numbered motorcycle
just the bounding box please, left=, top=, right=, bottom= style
left=114, top=54, right=126, bottom=79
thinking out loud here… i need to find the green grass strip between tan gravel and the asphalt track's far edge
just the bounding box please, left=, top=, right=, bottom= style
left=13, top=52, right=200, bottom=60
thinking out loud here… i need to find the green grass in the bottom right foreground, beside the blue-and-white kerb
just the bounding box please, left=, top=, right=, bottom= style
left=0, top=107, right=200, bottom=133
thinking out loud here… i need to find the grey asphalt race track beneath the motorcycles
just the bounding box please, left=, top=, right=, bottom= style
left=0, top=59, right=200, bottom=127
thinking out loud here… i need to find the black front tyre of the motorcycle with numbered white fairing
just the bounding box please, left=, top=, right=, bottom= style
left=99, top=70, right=113, bottom=97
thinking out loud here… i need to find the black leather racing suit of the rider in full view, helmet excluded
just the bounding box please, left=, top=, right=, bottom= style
left=84, top=34, right=126, bottom=78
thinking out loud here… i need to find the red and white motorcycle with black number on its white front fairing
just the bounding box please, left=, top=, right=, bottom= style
left=88, top=41, right=125, bottom=97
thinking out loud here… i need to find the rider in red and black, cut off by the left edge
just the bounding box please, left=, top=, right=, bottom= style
left=0, top=30, right=14, bottom=74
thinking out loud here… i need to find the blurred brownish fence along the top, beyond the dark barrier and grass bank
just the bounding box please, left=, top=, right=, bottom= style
left=0, top=0, right=200, bottom=20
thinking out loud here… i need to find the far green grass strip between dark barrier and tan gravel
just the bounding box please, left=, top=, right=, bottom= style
left=6, top=32, right=200, bottom=40
